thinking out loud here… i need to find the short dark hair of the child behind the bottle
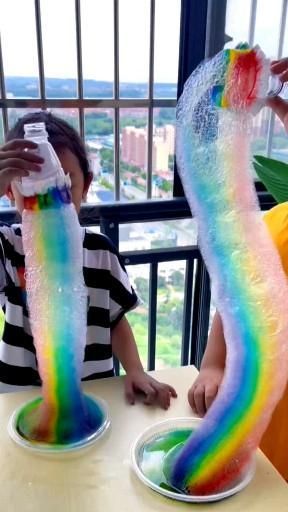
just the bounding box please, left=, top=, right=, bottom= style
left=6, top=110, right=89, bottom=178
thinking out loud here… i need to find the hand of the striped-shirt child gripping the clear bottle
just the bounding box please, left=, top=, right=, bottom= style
left=0, top=139, right=44, bottom=196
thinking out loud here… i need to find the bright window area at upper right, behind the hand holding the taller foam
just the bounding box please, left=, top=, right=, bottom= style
left=226, top=0, right=288, bottom=162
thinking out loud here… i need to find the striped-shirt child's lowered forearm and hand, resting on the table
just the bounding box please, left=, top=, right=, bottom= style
left=111, top=316, right=177, bottom=409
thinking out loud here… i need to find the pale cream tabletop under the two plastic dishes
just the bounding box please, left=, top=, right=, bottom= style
left=0, top=367, right=288, bottom=512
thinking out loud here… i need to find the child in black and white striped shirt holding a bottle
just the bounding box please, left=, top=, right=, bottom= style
left=0, top=112, right=176, bottom=409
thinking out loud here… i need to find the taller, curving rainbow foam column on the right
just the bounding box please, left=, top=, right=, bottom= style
left=164, top=48, right=288, bottom=495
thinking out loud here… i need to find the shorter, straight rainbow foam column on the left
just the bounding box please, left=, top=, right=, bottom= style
left=18, top=186, right=103, bottom=446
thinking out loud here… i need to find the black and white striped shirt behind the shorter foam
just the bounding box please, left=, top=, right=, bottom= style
left=0, top=225, right=138, bottom=386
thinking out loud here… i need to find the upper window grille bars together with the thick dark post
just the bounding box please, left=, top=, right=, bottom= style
left=0, top=0, right=288, bottom=201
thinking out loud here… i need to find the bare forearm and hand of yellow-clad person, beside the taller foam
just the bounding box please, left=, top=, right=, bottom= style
left=188, top=313, right=226, bottom=416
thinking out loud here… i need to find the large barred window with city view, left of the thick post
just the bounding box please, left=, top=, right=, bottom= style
left=0, top=0, right=181, bottom=202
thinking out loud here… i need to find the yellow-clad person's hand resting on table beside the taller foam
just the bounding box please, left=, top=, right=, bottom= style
left=188, top=368, right=223, bottom=417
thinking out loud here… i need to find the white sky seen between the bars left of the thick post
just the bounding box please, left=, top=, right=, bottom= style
left=0, top=0, right=181, bottom=83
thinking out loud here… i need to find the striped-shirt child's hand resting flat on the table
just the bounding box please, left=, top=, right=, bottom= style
left=125, top=370, right=177, bottom=409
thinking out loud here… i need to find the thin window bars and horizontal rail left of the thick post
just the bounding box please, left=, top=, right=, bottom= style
left=0, top=0, right=180, bottom=201
